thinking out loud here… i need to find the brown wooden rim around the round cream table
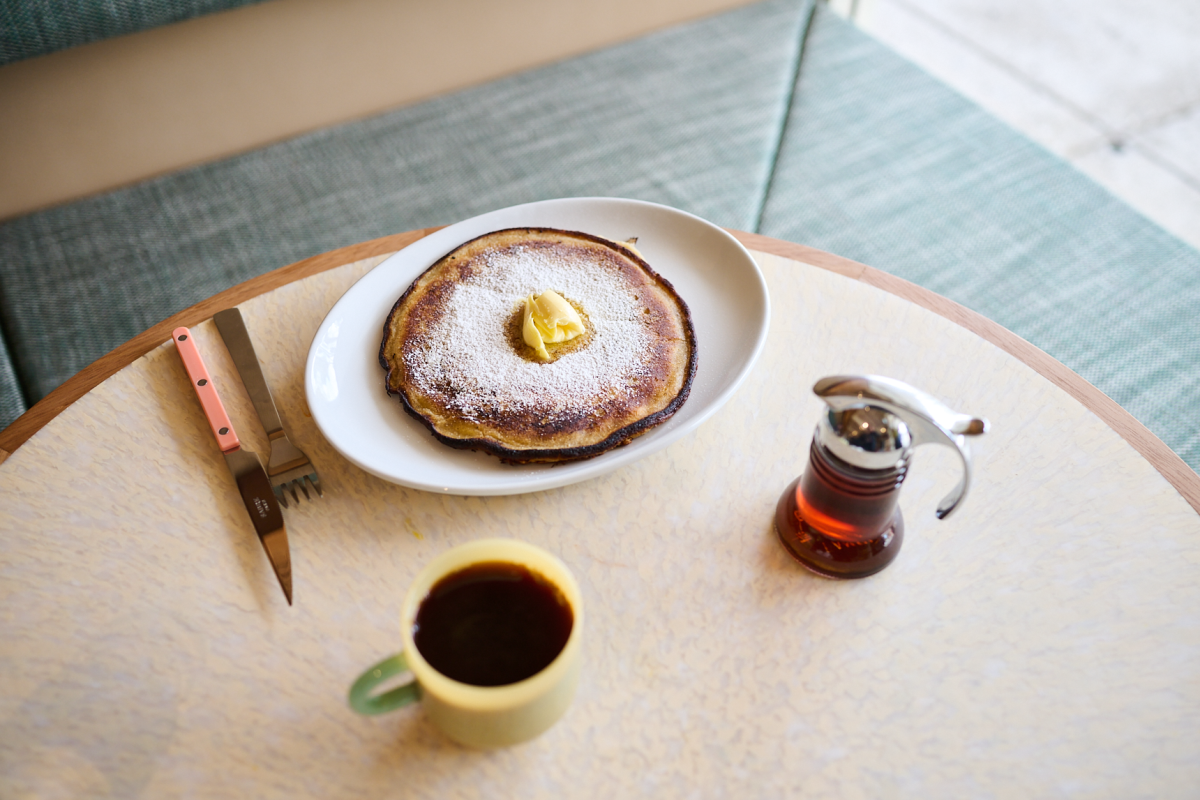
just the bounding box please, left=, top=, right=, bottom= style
left=0, top=228, right=1200, bottom=513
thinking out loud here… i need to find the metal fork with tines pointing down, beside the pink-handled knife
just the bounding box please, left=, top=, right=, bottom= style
left=212, top=308, right=325, bottom=509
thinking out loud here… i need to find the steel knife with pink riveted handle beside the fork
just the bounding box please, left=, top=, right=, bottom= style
left=172, top=327, right=292, bottom=606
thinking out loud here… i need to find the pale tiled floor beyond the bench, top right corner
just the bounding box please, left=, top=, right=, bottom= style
left=830, top=0, right=1200, bottom=247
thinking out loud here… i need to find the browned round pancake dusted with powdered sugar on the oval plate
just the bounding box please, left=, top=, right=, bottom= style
left=379, top=228, right=696, bottom=464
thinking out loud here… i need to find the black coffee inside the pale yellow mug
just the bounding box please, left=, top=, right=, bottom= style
left=413, top=561, right=575, bottom=686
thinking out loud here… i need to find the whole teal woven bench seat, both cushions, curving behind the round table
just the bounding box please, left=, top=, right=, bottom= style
left=0, top=0, right=1200, bottom=469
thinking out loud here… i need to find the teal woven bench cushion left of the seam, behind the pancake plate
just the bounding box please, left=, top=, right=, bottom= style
left=0, top=0, right=811, bottom=402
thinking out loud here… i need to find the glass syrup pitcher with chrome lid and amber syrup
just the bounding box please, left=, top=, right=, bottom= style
left=775, top=375, right=988, bottom=578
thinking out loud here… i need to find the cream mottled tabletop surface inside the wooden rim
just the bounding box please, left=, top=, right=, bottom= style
left=0, top=247, right=1200, bottom=798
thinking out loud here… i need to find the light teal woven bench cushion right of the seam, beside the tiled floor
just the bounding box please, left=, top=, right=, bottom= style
left=761, top=10, right=1200, bottom=470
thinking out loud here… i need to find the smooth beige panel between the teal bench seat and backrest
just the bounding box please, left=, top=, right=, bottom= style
left=0, top=0, right=746, bottom=219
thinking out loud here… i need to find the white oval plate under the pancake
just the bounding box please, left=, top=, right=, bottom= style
left=305, top=198, right=770, bottom=494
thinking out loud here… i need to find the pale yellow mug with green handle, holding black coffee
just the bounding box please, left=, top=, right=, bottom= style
left=349, top=539, right=583, bottom=748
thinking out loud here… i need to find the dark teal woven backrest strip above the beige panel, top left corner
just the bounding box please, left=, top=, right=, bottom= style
left=0, top=0, right=262, bottom=65
